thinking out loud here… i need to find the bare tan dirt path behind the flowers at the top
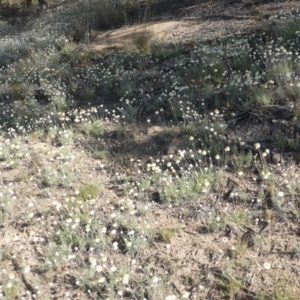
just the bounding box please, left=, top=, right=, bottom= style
left=92, top=0, right=300, bottom=50
